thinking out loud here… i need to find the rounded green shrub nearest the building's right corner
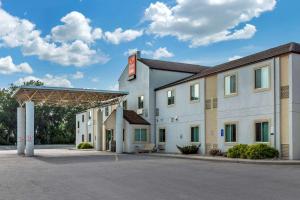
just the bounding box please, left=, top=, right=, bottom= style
left=246, top=144, right=279, bottom=159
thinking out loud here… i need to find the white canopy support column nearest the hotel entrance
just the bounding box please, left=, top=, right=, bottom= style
left=116, top=106, right=123, bottom=153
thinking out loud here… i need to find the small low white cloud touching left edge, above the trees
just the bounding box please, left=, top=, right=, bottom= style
left=0, top=56, right=33, bottom=74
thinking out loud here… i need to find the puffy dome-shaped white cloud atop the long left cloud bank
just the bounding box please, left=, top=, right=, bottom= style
left=51, top=11, right=102, bottom=43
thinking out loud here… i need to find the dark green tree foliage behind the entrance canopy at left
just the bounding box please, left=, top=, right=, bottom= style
left=0, top=81, right=84, bottom=145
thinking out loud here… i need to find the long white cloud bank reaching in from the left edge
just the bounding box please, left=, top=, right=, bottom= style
left=0, top=8, right=109, bottom=67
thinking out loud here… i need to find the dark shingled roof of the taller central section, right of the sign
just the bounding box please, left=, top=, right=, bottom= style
left=138, top=58, right=208, bottom=74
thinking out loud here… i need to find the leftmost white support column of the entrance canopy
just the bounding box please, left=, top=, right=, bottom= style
left=17, top=107, right=25, bottom=155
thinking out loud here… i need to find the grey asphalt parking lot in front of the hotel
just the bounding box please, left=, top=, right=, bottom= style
left=0, top=148, right=300, bottom=200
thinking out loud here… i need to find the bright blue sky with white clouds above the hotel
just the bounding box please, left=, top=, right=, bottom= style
left=0, top=0, right=300, bottom=89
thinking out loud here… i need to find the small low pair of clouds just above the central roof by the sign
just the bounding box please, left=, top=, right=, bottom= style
left=124, top=47, right=174, bottom=59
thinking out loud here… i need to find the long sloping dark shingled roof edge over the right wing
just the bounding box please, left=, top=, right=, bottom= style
left=155, top=42, right=300, bottom=91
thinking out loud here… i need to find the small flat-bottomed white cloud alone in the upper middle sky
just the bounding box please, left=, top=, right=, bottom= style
left=104, top=28, right=143, bottom=44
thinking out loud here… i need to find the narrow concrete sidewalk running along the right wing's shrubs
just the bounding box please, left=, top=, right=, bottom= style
left=147, top=153, right=300, bottom=165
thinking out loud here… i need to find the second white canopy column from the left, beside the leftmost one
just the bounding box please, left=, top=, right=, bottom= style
left=25, top=101, right=34, bottom=156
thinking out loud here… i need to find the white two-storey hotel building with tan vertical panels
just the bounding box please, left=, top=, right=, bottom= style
left=76, top=43, right=300, bottom=159
